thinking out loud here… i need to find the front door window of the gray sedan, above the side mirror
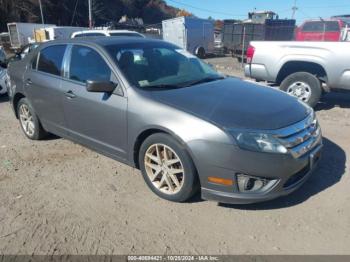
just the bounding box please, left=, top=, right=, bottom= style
left=69, top=45, right=116, bottom=83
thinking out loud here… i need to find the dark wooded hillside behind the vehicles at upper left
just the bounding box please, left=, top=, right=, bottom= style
left=0, top=0, right=180, bottom=32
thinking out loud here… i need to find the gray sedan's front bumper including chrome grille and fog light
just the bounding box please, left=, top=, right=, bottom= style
left=189, top=113, right=323, bottom=204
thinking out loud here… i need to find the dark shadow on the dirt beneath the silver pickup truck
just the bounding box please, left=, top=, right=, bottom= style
left=315, top=91, right=350, bottom=111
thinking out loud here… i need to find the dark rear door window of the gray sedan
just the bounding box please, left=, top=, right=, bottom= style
left=38, top=45, right=66, bottom=76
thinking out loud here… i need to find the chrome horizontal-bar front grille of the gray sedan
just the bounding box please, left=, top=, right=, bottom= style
left=276, top=113, right=322, bottom=158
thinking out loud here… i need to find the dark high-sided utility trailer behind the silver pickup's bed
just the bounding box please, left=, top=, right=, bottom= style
left=223, top=19, right=296, bottom=59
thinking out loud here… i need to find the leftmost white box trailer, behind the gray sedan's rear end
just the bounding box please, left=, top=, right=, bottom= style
left=7, top=23, right=55, bottom=49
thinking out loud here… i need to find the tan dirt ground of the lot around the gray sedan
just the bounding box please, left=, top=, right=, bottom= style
left=0, top=58, right=350, bottom=255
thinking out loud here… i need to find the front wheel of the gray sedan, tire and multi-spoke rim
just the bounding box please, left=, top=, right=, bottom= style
left=139, top=133, right=199, bottom=202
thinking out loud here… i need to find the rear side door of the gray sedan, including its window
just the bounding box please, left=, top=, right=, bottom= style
left=24, top=45, right=67, bottom=134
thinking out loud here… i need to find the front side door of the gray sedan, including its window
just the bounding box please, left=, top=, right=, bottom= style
left=62, top=45, right=127, bottom=159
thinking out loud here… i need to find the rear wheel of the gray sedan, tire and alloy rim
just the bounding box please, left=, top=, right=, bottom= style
left=17, top=98, right=47, bottom=140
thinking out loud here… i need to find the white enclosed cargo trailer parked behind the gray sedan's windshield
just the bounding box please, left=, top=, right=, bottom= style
left=162, top=17, right=214, bottom=58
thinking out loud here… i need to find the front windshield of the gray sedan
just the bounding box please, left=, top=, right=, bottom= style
left=106, top=42, right=222, bottom=88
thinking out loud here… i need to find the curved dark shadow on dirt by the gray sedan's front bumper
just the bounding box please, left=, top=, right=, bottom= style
left=219, top=138, right=346, bottom=210
